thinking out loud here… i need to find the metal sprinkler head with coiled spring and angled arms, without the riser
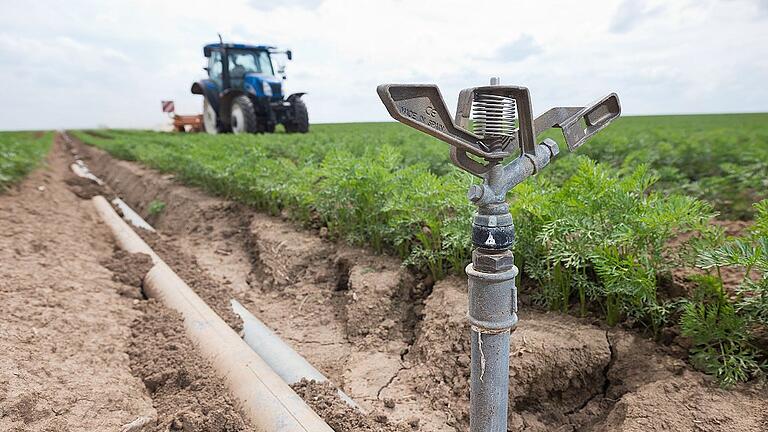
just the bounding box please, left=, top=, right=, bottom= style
left=377, top=81, right=621, bottom=177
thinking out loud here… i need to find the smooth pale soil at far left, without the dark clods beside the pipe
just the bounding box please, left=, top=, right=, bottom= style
left=0, top=136, right=156, bottom=432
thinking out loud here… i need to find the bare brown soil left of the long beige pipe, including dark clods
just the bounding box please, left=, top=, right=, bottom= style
left=0, top=137, right=252, bottom=432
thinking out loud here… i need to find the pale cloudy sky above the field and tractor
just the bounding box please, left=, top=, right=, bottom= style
left=0, top=0, right=768, bottom=130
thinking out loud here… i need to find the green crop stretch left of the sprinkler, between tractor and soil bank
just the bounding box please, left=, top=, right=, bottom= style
left=75, top=125, right=472, bottom=279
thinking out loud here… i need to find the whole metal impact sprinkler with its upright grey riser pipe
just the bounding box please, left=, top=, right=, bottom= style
left=377, top=78, right=621, bottom=432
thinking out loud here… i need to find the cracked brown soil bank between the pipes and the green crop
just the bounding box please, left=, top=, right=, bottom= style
left=21, top=133, right=768, bottom=431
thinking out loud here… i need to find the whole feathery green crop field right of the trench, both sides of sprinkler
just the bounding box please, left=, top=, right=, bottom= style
left=76, top=114, right=768, bottom=386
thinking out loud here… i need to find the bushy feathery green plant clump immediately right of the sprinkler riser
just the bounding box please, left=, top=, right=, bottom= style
left=512, top=157, right=713, bottom=333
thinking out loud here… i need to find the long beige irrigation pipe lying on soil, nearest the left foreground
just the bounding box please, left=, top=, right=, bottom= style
left=92, top=196, right=333, bottom=432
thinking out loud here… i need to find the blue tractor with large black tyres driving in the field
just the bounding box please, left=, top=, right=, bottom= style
left=192, top=42, right=309, bottom=134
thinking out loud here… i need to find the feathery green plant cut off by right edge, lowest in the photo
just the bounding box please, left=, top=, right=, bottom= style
left=681, top=200, right=768, bottom=386
